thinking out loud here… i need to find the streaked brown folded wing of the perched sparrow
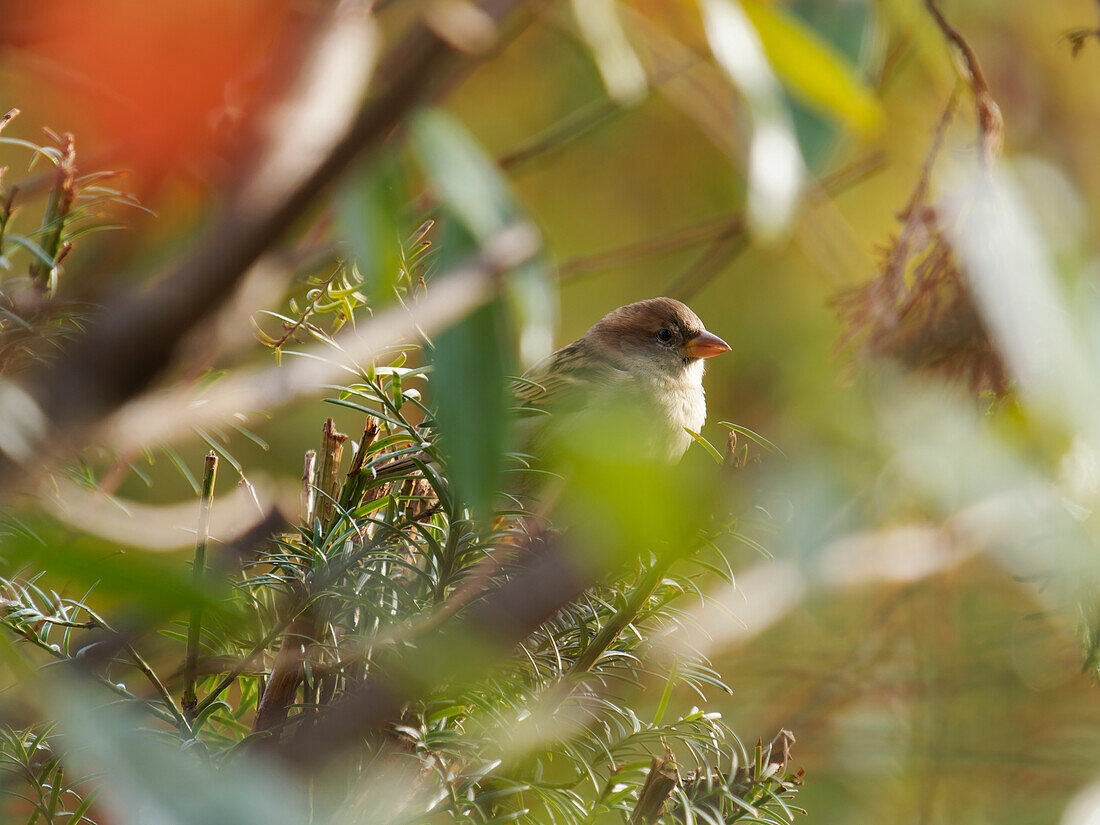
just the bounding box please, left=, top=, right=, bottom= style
left=513, top=339, right=622, bottom=415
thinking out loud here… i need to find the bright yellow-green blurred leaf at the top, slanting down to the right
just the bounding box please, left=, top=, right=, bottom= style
left=740, top=0, right=882, bottom=135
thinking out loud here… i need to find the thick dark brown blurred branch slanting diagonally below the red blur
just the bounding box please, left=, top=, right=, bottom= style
left=0, top=0, right=542, bottom=490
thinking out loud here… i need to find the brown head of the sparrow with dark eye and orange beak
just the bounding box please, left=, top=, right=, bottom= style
left=585, top=298, right=730, bottom=376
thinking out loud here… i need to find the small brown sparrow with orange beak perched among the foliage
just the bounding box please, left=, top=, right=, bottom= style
left=516, top=298, right=730, bottom=462
